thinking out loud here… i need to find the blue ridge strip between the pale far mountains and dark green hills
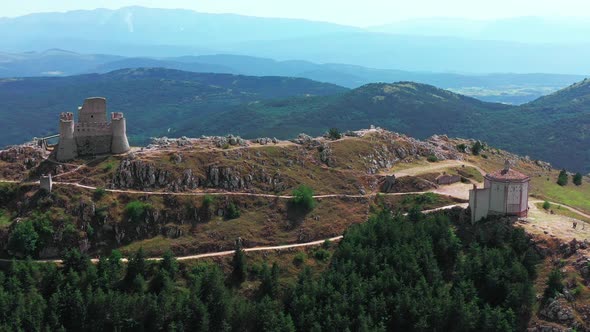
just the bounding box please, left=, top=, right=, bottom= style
left=0, top=49, right=584, bottom=104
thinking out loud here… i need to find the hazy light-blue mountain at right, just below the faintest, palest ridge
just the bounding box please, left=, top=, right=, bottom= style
left=218, top=32, right=590, bottom=74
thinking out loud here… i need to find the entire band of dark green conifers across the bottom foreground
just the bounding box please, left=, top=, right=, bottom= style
left=0, top=206, right=536, bottom=331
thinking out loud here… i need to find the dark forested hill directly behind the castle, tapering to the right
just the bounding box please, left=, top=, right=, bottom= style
left=0, top=68, right=346, bottom=145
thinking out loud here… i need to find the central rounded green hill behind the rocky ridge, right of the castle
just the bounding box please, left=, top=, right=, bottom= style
left=177, top=82, right=509, bottom=138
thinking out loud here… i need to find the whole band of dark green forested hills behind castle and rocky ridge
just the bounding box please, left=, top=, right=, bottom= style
left=0, top=69, right=590, bottom=173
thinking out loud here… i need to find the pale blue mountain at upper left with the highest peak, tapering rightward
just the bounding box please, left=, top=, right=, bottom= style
left=0, top=7, right=358, bottom=50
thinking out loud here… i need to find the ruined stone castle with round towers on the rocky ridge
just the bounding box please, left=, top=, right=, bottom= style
left=56, top=97, right=129, bottom=161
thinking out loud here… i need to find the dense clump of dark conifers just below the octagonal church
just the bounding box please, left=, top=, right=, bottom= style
left=288, top=212, right=537, bottom=331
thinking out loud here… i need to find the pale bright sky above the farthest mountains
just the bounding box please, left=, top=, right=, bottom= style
left=0, top=0, right=590, bottom=27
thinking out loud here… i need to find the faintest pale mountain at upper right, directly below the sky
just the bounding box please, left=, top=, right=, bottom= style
left=368, top=17, right=590, bottom=44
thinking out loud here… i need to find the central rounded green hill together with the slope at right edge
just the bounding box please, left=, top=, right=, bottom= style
left=176, top=80, right=590, bottom=172
